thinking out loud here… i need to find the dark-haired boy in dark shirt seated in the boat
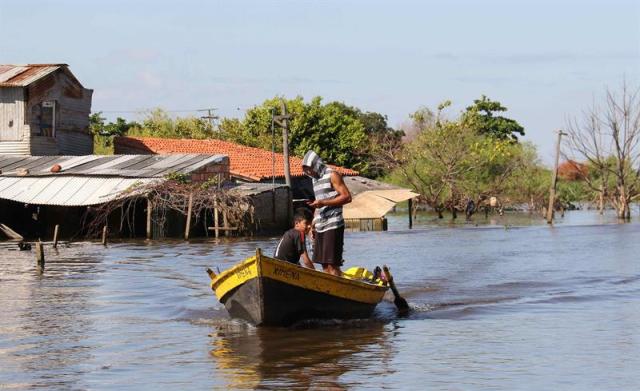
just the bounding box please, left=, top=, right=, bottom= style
left=275, top=208, right=315, bottom=269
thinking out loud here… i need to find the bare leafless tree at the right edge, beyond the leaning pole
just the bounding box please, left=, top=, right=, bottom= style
left=565, top=82, right=640, bottom=220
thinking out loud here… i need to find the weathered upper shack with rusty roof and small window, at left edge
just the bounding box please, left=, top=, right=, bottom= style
left=0, top=64, right=93, bottom=155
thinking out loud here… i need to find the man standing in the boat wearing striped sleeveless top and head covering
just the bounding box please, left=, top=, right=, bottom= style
left=302, top=151, right=351, bottom=276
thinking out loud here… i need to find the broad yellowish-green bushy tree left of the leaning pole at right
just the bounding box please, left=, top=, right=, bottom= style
left=381, top=101, right=548, bottom=217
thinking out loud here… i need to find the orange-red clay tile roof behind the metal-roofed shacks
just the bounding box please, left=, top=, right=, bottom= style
left=114, top=137, right=358, bottom=181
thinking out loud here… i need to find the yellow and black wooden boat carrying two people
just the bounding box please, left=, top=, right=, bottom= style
left=207, top=249, right=389, bottom=326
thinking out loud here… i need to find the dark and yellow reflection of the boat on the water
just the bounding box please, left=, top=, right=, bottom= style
left=211, top=320, right=393, bottom=389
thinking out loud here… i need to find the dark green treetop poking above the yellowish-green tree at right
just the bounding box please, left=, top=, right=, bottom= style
left=462, top=95, right=524, bottom=141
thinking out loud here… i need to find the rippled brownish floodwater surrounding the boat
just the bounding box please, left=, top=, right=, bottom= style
left=0, top=212, right=640, bottom=390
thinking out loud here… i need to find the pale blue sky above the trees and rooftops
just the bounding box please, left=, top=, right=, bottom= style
left=0, top=0, right=640, bottom=162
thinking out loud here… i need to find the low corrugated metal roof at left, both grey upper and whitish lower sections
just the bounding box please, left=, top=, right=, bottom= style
left=0, top=154, right=228, bottom=206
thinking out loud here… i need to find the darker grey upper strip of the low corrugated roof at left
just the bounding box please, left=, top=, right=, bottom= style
left=0, top=154, right=228, bottom=178
